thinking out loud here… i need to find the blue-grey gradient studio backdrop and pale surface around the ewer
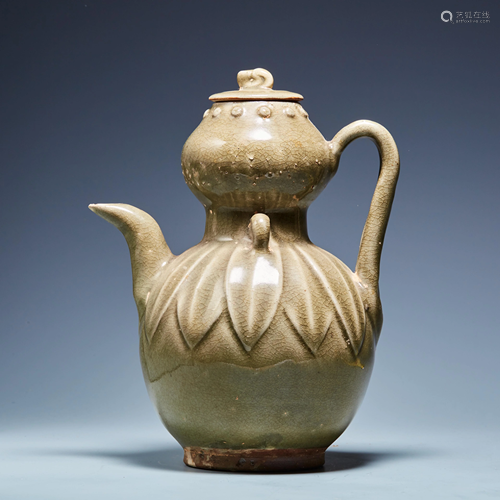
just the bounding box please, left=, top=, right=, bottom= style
left=0, top=0, right=500, bottom=499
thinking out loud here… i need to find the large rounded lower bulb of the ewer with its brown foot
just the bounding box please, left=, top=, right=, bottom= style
left=140, top=221, right=382, bottom=470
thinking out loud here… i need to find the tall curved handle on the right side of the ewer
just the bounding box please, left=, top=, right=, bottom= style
left=330, top=120, right=399, bottom=290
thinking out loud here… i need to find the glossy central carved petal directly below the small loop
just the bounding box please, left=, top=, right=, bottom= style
left=226, top=237, right=283, bottom=351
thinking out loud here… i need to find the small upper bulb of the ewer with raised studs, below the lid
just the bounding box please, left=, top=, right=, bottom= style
left=182, top=101, right=337, bottom=212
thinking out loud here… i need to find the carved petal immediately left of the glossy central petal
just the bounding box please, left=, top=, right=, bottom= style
left=177, top=244, right=234, bottom=349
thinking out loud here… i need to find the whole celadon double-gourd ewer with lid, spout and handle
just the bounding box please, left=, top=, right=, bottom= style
left=90, top=68, right=399, bottom=471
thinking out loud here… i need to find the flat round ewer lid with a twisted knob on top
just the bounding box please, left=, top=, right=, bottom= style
left=209, top=68, right=304, bottom=102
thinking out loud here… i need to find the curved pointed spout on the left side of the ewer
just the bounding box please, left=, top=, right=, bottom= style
left=89, top=203, right=173, bottom=319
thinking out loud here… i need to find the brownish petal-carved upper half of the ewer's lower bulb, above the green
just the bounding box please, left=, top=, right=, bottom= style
left=142, top=223, right=370, bottom=372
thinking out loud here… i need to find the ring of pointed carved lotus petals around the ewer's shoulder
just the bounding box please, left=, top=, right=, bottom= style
left=143, top=237, right=366, bottom=358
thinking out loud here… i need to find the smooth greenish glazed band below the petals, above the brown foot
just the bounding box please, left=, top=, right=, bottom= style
left=145, top=358, right=373, bottom=450
